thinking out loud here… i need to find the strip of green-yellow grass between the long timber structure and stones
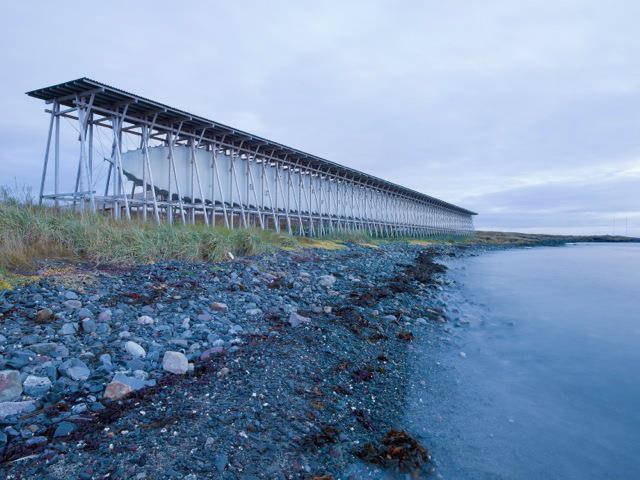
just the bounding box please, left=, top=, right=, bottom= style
left=0, top=187, right=470, bottom=290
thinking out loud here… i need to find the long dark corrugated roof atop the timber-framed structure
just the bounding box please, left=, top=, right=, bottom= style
left=27, top=77, right=476, bottom=215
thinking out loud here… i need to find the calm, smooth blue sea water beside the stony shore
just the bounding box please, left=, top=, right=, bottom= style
left=408, top=244, right=640, bottom=480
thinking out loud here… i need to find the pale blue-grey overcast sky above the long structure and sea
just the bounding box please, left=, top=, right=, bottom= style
left=0, top=0, right=640, bottom=235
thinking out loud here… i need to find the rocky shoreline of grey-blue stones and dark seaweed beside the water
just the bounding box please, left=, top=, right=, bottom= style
left=0, top=244, right=459, bottom=479
